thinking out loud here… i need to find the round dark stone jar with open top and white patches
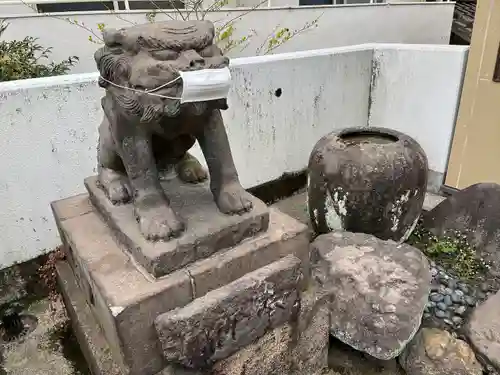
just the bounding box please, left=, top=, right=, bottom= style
left=307, top=127, right=427, bottom=242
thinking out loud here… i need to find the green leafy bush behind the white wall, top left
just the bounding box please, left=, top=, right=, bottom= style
left=0, top=21, right=78, bottom=81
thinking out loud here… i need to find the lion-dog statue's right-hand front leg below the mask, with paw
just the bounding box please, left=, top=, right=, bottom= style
left=197, top=110, right=252, bottom=214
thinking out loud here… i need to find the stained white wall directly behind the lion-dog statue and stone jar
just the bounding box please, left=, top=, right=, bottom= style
left=0, top=45, right=466, bottom=268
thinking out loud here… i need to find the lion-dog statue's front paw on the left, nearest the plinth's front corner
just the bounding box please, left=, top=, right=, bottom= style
left=136, top=203, right=184, bottom=241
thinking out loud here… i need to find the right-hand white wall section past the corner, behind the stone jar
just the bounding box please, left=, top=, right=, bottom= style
left=369, top=45, right=468, bottom=188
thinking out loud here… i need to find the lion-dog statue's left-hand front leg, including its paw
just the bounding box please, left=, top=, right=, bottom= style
left=113, top=122, right=184, bottom=240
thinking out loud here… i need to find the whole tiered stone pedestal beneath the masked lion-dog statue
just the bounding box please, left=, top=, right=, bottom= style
left=52, top=179, right=320, bottom=375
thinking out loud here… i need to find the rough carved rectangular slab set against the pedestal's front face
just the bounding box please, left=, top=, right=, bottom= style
left=155, top=255, right=302, bottom=369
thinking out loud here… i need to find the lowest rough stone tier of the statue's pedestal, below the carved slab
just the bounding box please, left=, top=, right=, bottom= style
left=56, top=263, right=329, bottom=375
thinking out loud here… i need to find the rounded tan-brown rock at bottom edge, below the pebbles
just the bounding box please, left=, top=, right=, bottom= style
left=399, top=328, right=483, bottom=375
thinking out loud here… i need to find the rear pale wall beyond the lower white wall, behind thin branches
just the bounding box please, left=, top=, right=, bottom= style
left=2, top=3, right=454, bottom=73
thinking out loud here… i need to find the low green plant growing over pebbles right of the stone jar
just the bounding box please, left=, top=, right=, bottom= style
left=407, top=221, right=489, bottom=281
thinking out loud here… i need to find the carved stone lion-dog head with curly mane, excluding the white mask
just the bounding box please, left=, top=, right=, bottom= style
left=94, top=21, right=229, bottom=122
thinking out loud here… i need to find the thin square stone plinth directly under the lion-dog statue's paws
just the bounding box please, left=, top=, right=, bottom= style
left=85, top=177, right=269, bottom=277
